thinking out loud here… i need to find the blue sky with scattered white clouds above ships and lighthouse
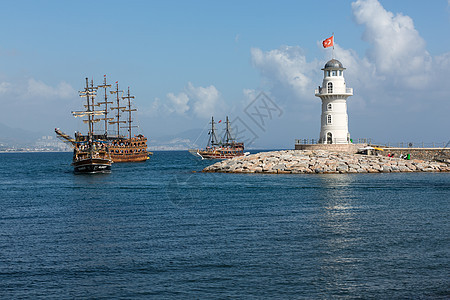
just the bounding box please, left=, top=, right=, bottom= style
left=0, top=0, right=450, bottom=149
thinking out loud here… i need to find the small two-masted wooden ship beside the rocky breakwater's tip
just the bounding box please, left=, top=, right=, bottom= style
left=189, top=117, right=249, bottom=159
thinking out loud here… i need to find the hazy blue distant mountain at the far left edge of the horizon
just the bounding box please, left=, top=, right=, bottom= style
left=0, top=123, right=43, bottom=147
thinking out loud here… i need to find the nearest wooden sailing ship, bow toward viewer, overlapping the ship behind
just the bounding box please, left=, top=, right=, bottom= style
left=55, top=78, right=112, bottom=173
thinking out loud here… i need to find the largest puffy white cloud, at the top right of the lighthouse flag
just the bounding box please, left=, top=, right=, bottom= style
left=352, top=0, right=432, bottom=87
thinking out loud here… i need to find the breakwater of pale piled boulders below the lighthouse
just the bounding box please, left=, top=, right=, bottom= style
left=203, top=150, right=450, bottom=174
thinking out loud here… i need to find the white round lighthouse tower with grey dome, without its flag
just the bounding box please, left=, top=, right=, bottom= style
left=315, top=58, right=353, bottom=144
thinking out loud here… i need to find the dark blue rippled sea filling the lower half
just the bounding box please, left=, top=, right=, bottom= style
left=0, top=151, right=450, bottom=299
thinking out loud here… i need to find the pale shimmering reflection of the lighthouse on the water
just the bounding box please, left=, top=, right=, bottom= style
left=318, top=174, right=361, bottom=295
